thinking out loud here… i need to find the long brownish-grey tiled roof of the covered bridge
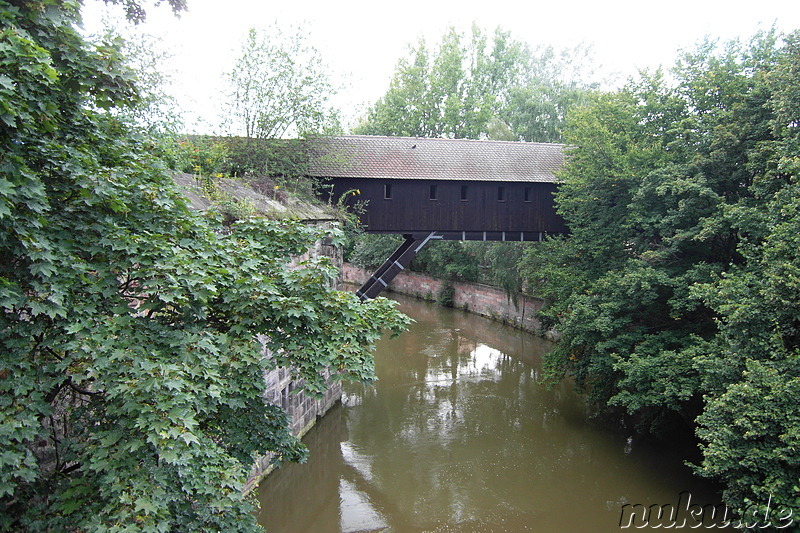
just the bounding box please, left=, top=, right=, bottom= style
left=310, top=135, right=564, bottom=182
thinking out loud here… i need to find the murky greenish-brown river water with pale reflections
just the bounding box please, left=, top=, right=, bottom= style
left=259, top=299, right=732, bottom=533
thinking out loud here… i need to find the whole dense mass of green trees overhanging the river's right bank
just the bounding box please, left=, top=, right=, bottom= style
left=523, top=32, right=800, bottom=516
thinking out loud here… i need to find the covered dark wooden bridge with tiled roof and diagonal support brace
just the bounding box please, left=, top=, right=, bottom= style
left=309, top=136, right=567, bottom=299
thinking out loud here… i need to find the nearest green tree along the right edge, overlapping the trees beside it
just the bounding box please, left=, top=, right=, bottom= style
left=696, top=32, right=800, bottom=517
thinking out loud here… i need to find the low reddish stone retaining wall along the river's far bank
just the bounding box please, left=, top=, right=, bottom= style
left=341, top=263, right=557, bottom=340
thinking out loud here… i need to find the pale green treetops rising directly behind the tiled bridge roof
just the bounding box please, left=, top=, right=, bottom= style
left=355, top=26, right=594, bottom=142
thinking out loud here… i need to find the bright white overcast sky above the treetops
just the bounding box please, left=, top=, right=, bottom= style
left=84, top=0, right=800, bottom=133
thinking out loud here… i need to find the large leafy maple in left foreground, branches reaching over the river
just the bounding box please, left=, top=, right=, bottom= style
left=0, top=0, right=405, bottom=532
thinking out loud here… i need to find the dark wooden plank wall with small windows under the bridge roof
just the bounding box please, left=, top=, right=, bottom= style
left=318, top=178, right=566, bottom=233
